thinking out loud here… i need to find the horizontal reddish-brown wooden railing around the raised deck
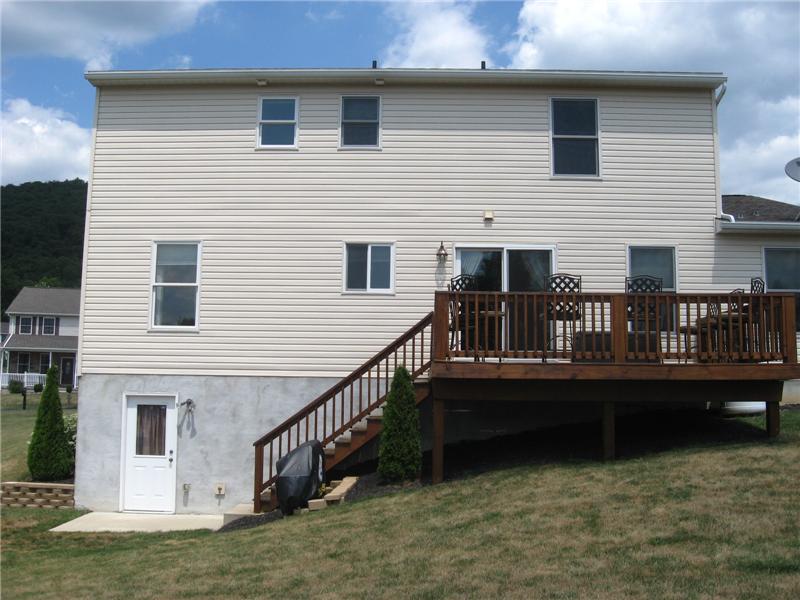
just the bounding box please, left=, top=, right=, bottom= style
left=434, top=292, right=797, bottom=364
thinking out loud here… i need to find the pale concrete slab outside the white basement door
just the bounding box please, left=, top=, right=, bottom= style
left=50, top=512, right=222, bottom=533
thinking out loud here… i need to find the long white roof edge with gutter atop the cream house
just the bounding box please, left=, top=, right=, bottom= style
left=84, top=68, right=727, bottom=89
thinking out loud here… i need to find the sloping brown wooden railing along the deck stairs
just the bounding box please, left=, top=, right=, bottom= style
left=253, top=313, right=433, bottom=512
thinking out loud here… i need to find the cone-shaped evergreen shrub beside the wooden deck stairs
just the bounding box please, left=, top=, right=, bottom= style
left=378, top=367, right=422, bottom=481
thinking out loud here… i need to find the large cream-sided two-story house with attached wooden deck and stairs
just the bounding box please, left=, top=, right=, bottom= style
left=76, top=69, right=800, bottom=512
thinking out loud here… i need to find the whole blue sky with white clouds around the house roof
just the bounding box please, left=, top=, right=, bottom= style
left=2, top=0, right=800, bottom=203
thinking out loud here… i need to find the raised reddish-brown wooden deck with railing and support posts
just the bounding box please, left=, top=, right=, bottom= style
left=430, top=292, right=800, bottom=482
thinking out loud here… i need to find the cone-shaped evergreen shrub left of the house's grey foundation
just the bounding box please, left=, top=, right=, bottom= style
left=28, top=365, right=75, bottom=481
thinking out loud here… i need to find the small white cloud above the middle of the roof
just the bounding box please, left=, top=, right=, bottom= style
left=383, top=2, right=489, bottom=67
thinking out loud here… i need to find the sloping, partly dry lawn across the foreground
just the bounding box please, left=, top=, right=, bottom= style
left=1, top=411, right=800, bottom=599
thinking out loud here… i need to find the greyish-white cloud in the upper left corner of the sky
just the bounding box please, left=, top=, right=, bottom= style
left=2, top=0, right=208, bottom=71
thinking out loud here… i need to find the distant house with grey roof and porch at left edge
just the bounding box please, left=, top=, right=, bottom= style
left=2, top=287, right=81, bottom=387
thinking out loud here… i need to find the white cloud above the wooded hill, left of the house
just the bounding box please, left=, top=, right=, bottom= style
left=1, top=98, right=92, bottom=184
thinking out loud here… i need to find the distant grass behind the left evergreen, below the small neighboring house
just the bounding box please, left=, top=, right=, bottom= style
left=0, top=390, right=78, bottom=481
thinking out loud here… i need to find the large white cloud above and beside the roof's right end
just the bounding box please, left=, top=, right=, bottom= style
left=505, top=0, right=800, bottom=203
